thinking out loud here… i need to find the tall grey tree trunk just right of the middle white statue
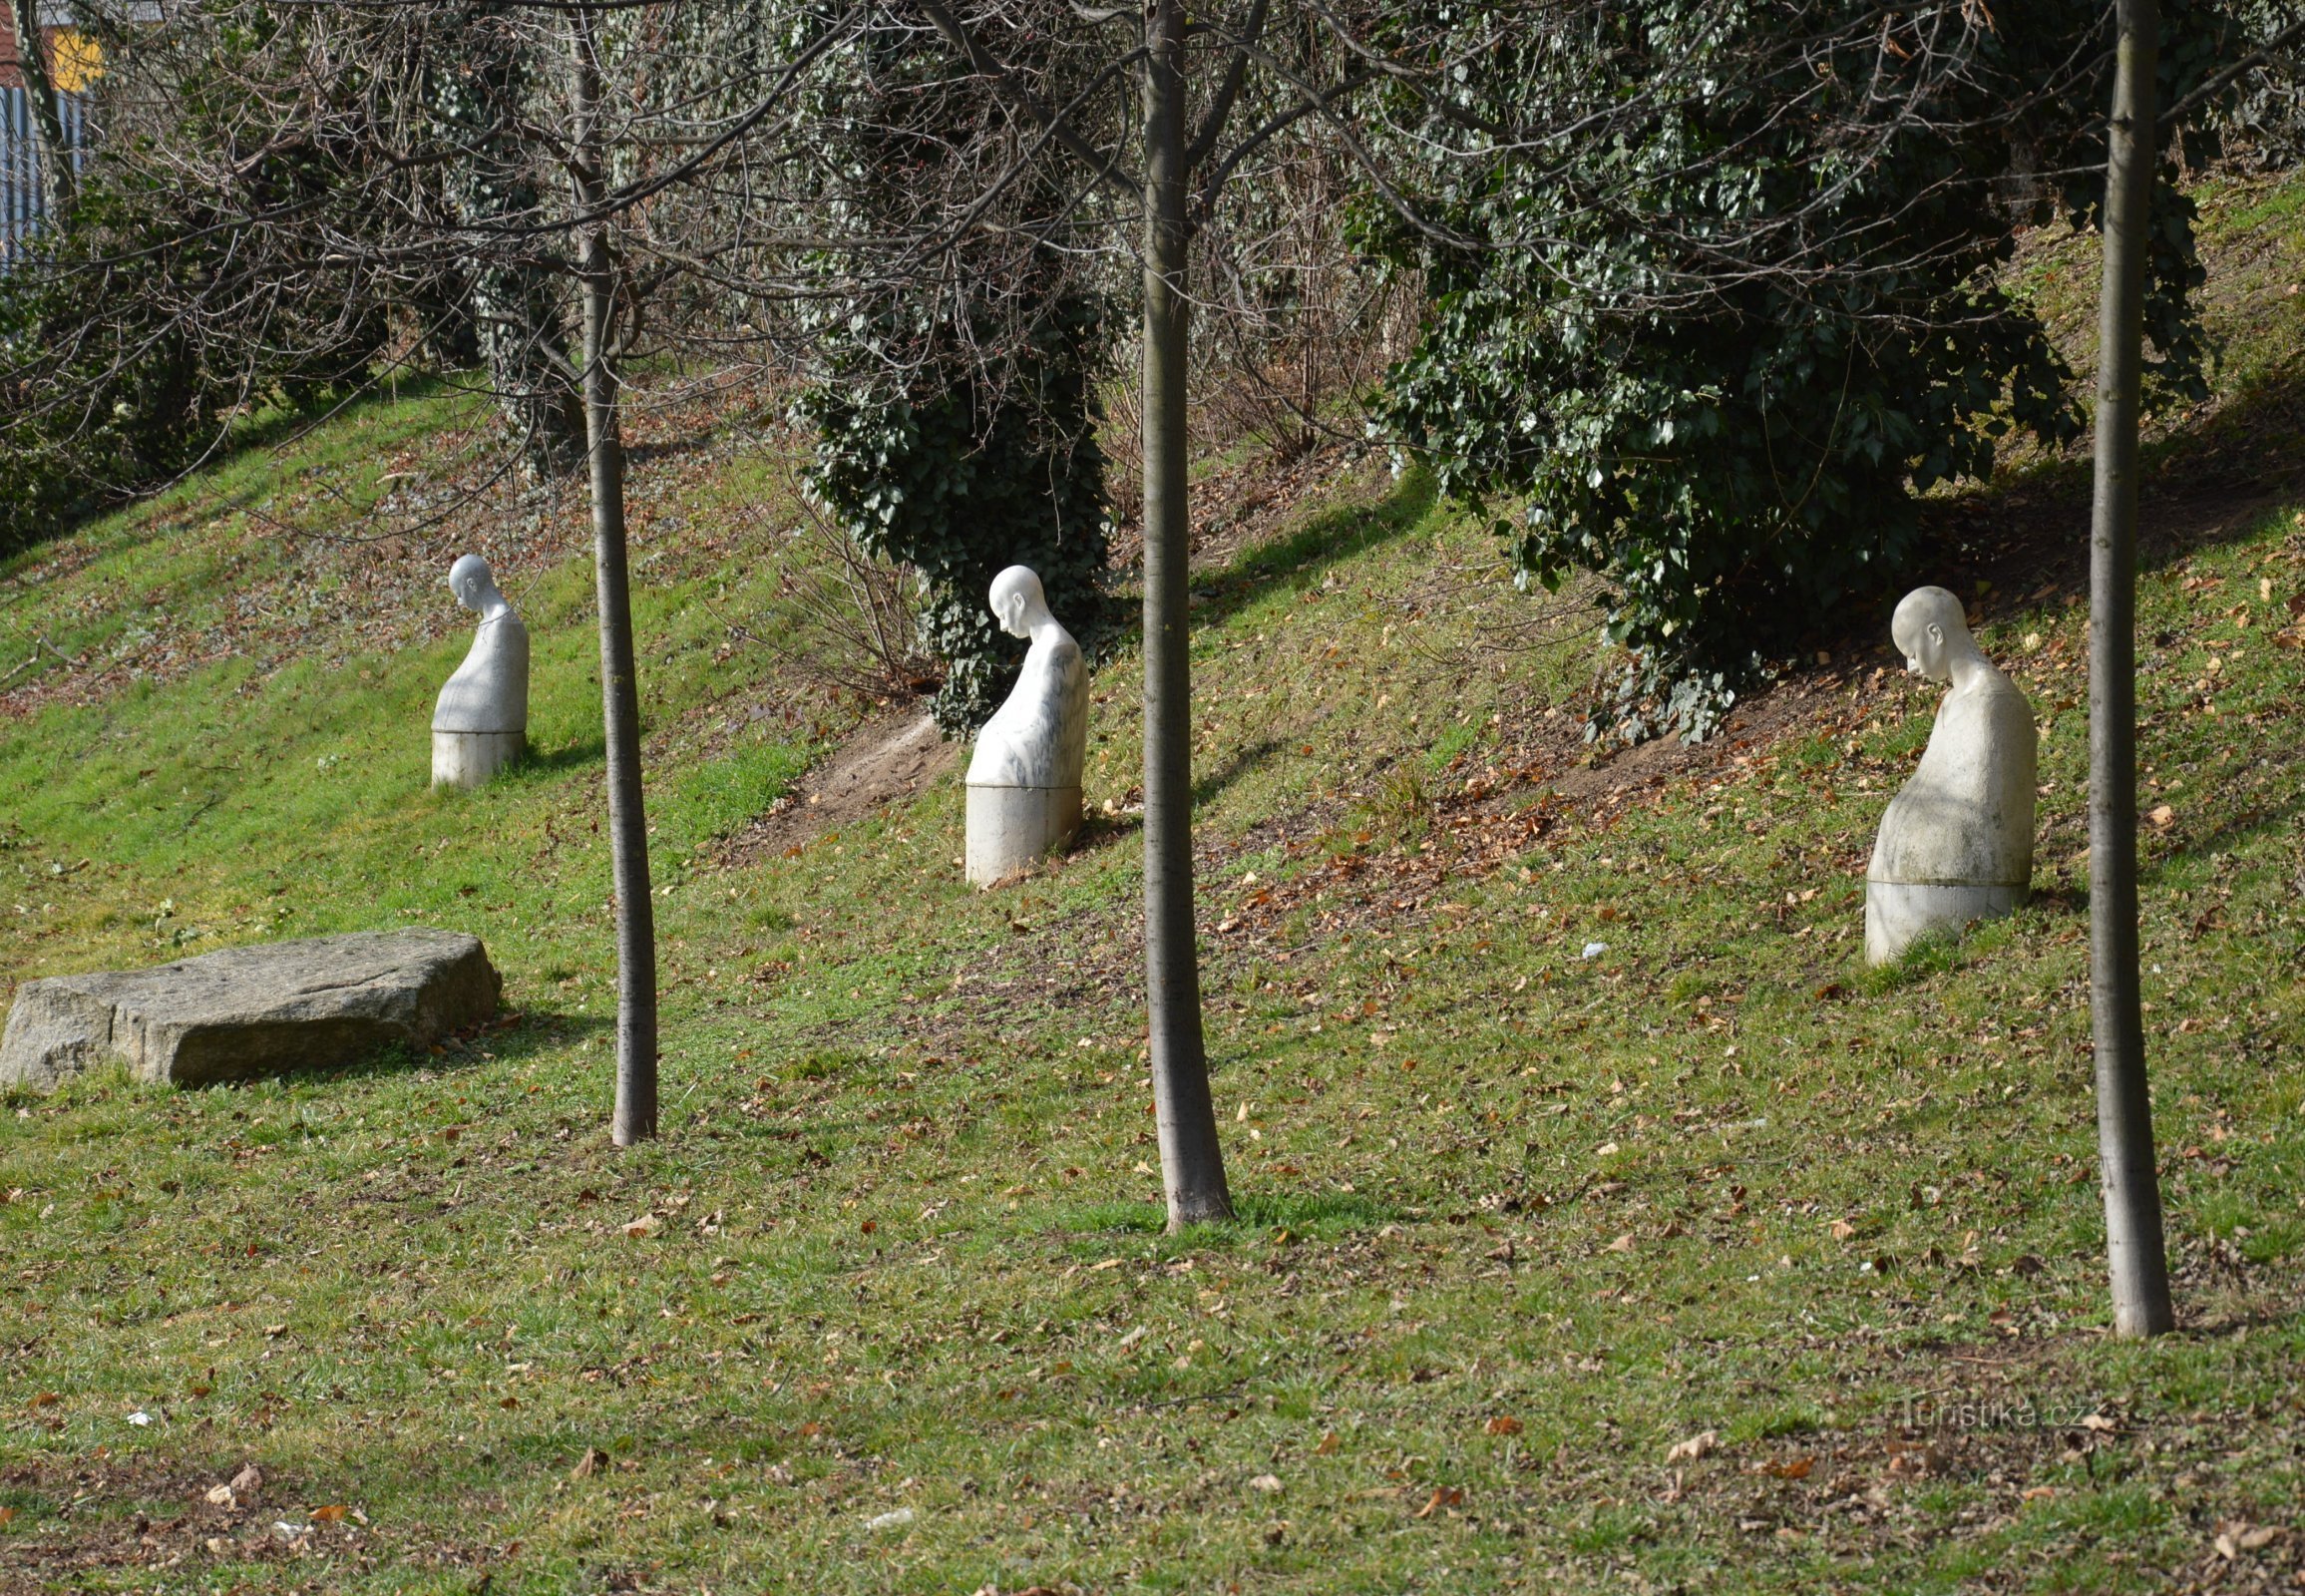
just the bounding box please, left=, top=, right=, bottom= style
left=1143, top=0, right=1233, bottom=1229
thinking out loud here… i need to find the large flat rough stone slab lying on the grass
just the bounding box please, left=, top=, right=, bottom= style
left=0, top=930, right=505, bottom=1088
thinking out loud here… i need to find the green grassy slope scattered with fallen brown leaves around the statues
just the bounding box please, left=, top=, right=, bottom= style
left=0, top=181, right=2305, bottom=1591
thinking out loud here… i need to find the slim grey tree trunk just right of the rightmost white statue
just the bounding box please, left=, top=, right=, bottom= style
left=2089, top=0, right=2176, bottom=1336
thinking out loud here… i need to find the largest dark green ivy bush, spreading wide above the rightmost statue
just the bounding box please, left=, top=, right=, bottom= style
left=1369, top=0, right=2224, bottom=736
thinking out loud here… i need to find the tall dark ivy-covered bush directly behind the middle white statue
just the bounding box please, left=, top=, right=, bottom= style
left=798, top=12, right=1109, bottom=733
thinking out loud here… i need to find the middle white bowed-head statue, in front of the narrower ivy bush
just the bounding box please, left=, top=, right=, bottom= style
left=968, top=565, right=1088, bottom=886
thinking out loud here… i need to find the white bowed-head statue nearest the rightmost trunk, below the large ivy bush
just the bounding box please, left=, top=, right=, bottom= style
left=1865, top=589, right=2036, bottom=964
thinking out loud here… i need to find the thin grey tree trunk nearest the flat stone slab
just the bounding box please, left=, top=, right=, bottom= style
left=570, top=9, right=657, bottom=1146
